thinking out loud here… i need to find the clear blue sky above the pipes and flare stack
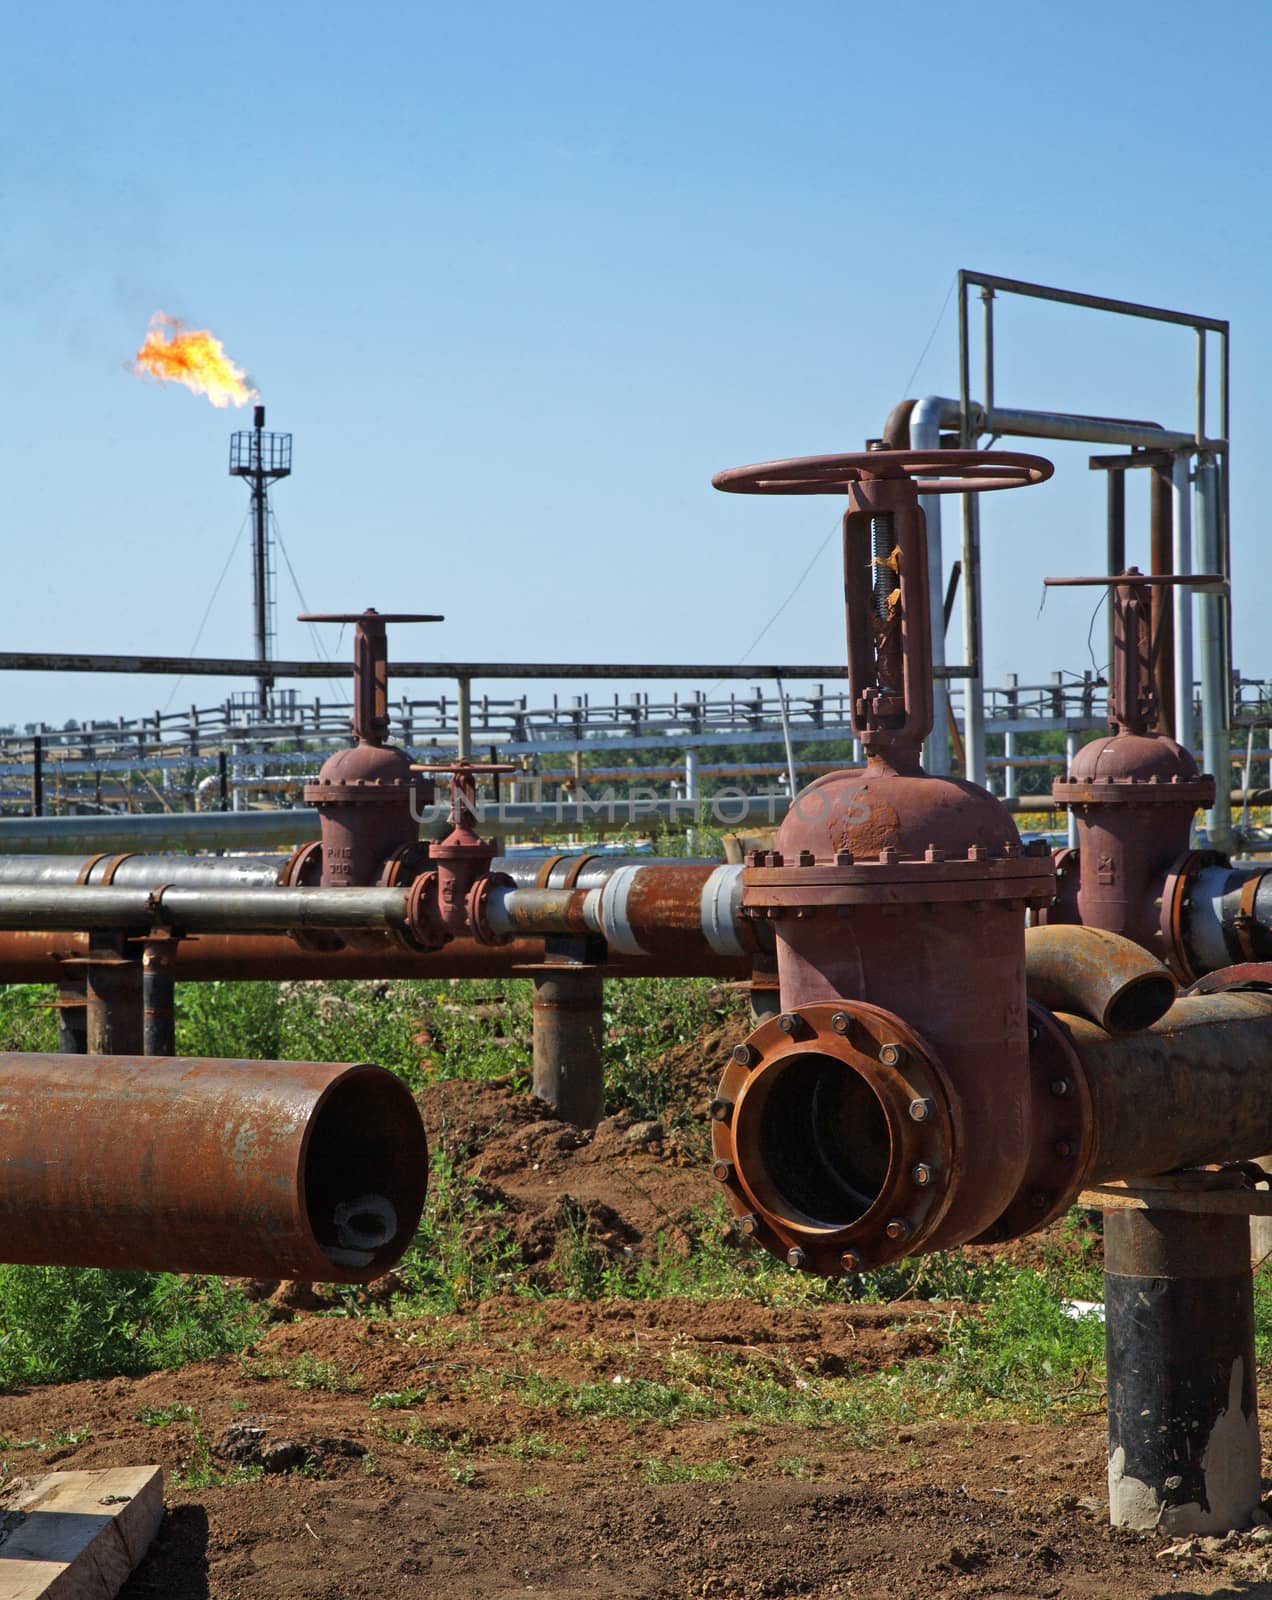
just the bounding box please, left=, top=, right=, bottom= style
left=0, top=0, right=1272, bottom=722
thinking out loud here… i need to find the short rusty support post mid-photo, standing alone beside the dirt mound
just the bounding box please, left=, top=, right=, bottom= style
left=533, top=965, right=605, bottom=1128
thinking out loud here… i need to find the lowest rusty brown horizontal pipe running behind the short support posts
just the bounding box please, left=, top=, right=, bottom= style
left=0, top=934, right=752, bottom=984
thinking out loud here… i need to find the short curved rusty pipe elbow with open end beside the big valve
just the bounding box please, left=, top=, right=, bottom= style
left=1024, top=923, right=1176, bottom=1034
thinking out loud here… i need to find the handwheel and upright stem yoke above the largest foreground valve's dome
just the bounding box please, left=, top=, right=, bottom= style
left=712, top=450, right=1054, bottom=760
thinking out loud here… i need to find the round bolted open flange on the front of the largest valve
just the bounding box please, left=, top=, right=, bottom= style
left=712, top=1002, right=954, bottom=1277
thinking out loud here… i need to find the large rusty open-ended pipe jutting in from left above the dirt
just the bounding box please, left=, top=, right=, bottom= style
left=0, top=1053, right=427, bottom=1283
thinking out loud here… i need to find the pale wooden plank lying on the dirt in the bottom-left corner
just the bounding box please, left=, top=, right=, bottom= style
left=0, top=1467, right=163, bottom=1600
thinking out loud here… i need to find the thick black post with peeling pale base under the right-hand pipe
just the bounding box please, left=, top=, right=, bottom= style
left=1104, top=1210, right=1262, bottom=1534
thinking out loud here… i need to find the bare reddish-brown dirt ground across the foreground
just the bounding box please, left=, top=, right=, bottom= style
left=0, top=1026, right=1272, bottom=1600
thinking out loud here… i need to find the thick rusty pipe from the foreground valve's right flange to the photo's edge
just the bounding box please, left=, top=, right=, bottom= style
left=1061, top=992, right=1272, bottom=1187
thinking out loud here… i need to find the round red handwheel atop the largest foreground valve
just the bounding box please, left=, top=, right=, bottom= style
left=710, top=450, right=1056, bottom=494
